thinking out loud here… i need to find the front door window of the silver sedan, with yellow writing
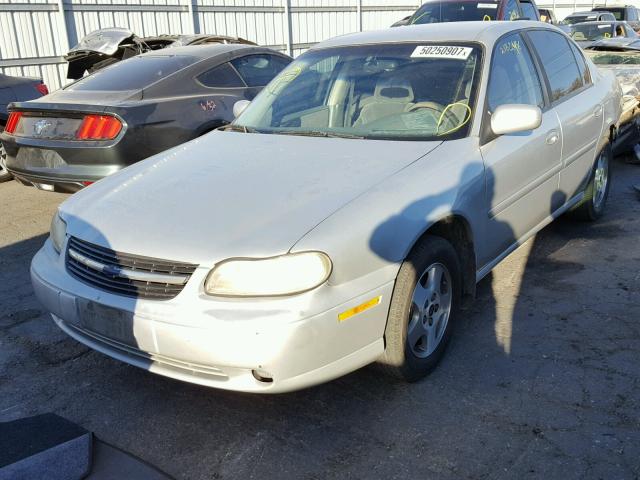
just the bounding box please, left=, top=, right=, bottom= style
left=488, top=34, right=544, bottom=112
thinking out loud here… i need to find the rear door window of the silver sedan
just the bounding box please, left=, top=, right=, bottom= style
left=528, top=30, right=583, bottom=102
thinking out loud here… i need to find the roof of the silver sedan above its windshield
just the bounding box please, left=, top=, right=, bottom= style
left=311, top=20, right=562, bottom=50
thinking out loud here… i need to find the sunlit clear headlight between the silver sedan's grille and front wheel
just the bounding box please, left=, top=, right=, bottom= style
left=204, top=252, right=331, bottom=297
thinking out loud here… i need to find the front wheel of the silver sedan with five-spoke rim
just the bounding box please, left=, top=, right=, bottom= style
left=381, top=235, right=462, bottom=382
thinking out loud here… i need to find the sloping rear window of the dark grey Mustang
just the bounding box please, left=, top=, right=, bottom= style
left=67, top=55, right=197, bottom=91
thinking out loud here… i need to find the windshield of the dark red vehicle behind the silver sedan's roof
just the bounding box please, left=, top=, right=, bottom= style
left=409, top=1, right=498, bottom=25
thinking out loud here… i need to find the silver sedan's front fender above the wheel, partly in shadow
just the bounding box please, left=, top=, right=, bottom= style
left=291, top=137, right=487, bottom=284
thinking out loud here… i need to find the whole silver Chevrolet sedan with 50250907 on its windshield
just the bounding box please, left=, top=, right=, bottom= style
left=31, top=21, right=621, bottom=393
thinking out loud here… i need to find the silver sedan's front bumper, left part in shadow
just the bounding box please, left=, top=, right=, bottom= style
left=31, top=241, right=393, bottom=393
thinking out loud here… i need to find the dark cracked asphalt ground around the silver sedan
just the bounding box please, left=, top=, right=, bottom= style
left=0, top=162, right=640, bottom=480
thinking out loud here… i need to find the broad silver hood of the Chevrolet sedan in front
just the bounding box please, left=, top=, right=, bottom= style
left=61, top=131, right=441, bottom=264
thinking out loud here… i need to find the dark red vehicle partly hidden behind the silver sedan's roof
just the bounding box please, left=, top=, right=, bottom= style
left=392, top=0, right=540, bottom=27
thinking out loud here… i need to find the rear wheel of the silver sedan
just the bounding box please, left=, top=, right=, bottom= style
left=572, top=145, right=613, bottom=222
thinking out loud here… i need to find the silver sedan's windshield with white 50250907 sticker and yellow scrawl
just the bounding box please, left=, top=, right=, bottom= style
left=233, top=44, right=481, bottom=140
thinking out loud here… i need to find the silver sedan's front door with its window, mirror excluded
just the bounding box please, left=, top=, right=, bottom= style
left=480, top=33, right=562, bottom=261
